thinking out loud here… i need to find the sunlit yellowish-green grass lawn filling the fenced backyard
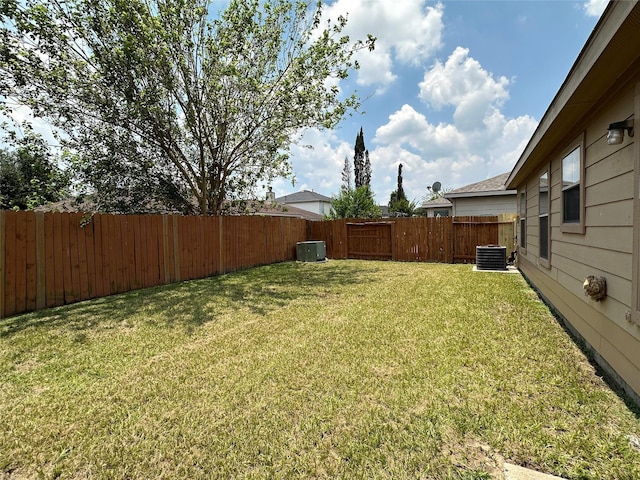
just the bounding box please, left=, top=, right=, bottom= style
left=0, top=261, right=640, bottom=479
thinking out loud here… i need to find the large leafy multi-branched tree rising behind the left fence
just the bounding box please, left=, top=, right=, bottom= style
left=0, top=0, right=375, bottom=214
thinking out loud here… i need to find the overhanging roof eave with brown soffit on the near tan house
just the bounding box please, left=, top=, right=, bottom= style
left=506, top=2, right=640, bottom=188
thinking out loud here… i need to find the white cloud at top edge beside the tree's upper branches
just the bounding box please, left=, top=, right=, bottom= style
left=324, top=0, right=444, bottom=92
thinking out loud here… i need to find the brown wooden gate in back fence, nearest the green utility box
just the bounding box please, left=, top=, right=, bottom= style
left=347, top=222, right=393, bottom=260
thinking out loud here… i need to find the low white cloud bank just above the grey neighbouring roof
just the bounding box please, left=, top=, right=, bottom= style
left=370, top=101, right=537, bottom=203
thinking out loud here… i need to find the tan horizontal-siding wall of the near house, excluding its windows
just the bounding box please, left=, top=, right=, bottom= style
left=518, top=75, right=640, bottom=402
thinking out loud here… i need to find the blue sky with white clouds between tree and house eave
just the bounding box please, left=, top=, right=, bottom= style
left=273, top=0, right=607, bottom=205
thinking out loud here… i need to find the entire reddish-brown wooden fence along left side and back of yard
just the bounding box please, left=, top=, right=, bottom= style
left=0, top=211, right=515, bottom=318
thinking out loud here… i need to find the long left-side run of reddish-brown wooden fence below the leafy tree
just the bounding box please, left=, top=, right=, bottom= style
left=0, top=211, right=306, bottom=318
